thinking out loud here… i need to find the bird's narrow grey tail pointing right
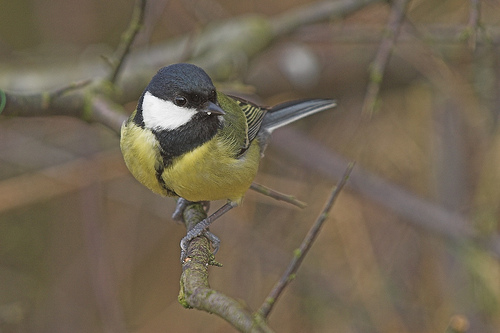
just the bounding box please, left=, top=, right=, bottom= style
left=262, top=99, right=337, bottom=134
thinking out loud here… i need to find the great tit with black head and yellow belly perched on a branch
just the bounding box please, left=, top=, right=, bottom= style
left=120, top=63, right=336, bottom=260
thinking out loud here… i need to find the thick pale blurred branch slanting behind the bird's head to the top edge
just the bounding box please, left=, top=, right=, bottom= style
left=0, top=0, right=380, bottom=93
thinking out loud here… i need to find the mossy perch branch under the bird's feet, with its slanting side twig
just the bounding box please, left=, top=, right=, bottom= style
left=179, top=163, right=354, bottom=332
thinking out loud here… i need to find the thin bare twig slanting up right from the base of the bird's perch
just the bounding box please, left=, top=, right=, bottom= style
left=257, top=162, right=355, bottom=318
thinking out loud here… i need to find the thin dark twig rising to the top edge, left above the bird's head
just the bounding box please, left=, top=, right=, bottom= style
left=108, top=0, right=146, bottom=83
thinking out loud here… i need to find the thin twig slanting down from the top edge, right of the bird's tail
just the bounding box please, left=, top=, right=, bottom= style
left=362, top=0, right=410, bottom=117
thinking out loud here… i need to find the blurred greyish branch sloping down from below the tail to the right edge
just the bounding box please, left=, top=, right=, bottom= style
left=273, top=128, right=500, bottom=258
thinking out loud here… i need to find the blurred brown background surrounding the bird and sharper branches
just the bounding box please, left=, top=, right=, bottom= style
left=0, top=0, right=500, bottom=332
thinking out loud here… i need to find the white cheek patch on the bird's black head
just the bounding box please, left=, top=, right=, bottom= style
left=142, top=92, right=197, bottom=130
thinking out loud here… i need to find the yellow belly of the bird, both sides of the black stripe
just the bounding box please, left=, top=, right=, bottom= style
left=120, top=123, right=260, bottom=203
